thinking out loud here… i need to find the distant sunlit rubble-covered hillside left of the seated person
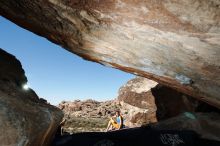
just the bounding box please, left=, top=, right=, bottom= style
left=58, top=99, right=120, bottom=133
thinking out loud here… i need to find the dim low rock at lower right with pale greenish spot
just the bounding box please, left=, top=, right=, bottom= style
left=153, top=112, right=220, bottom=141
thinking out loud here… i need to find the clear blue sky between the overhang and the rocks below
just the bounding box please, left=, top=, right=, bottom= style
left=0, top=16, right=134, bottom=105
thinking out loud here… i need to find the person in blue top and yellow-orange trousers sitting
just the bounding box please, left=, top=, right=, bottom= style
left=106, top=111, right=123, bottom=131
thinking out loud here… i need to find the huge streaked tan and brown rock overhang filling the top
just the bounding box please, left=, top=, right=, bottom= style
left=0, top=0, right=220, bottom=108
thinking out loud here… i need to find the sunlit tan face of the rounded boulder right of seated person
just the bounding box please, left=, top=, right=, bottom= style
left=118, top=77, right=158, bottom=127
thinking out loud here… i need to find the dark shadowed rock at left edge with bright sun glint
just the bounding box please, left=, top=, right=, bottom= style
left=0, top=49, right=63, bottom=146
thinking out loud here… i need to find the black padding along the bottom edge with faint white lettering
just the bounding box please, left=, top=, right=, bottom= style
left=52, top=126, right=220, bottom=146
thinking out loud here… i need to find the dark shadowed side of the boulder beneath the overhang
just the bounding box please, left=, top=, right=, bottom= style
left=151, top=85, right=219, bottom=121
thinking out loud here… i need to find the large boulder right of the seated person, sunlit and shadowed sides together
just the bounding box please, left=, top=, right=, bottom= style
left=118, top=77, right=219, bottom=127
